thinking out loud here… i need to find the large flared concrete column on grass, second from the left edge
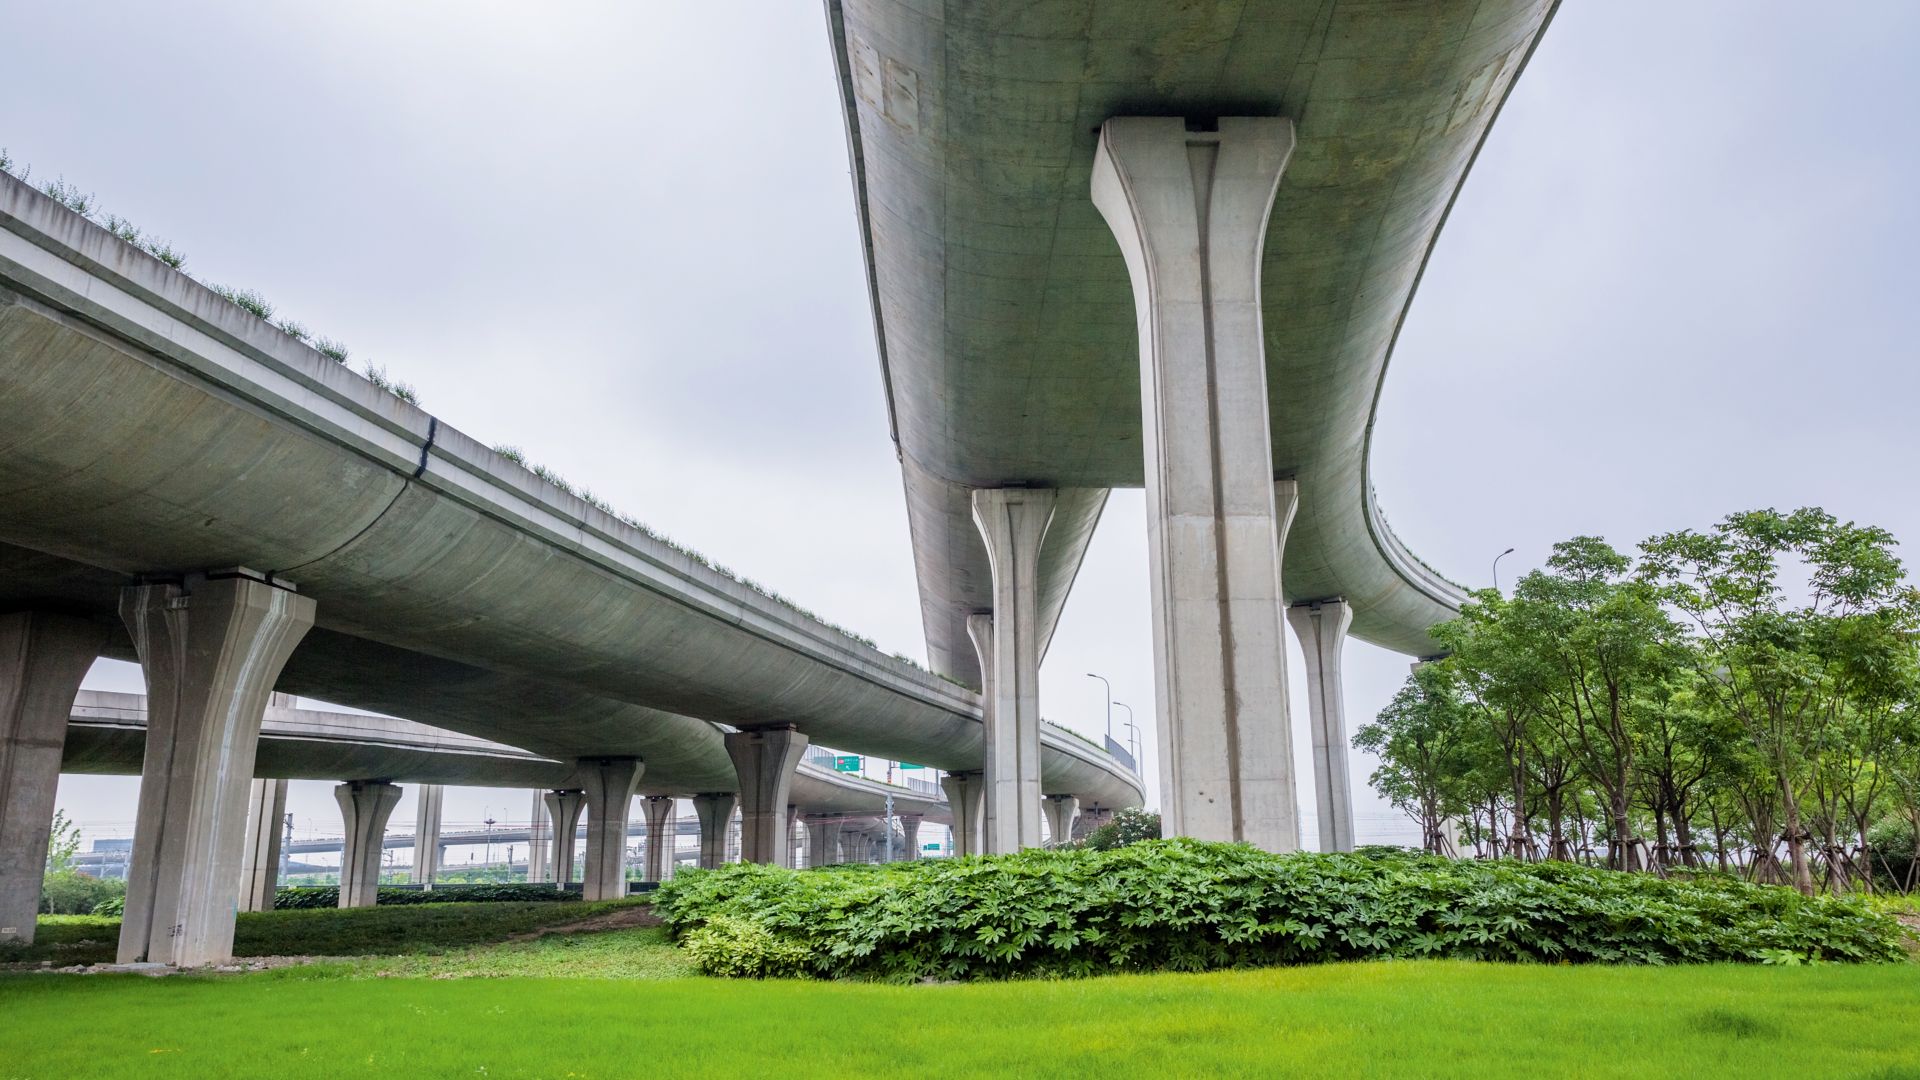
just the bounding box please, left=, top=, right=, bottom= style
left=119, top=571, right=313, bottom=967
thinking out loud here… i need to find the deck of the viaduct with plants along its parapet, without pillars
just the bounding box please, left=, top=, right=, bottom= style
left=0, top=177, right=1139, bottom=799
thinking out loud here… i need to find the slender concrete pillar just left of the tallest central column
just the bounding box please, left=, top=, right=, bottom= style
left=968, top=488, right=1056, bottom=853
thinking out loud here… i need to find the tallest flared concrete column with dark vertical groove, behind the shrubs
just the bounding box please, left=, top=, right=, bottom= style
left=1092, top=117, right=1300, bottom=851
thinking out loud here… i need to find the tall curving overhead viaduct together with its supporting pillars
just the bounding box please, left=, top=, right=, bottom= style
left=826, top=0, right=1555, bottom=851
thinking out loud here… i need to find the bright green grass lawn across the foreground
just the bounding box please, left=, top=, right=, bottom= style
left=0, top=905, right=1920, bottom=1080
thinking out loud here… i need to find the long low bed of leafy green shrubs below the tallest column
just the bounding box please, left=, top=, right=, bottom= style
left=655, top=840, right=1905, bottom=980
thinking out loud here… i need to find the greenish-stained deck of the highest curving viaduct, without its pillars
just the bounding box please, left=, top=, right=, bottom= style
left=828, top=0, right=1555, bottom=682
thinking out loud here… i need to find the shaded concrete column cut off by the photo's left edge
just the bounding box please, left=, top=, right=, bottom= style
left=0, top=611, right=108, bottom=942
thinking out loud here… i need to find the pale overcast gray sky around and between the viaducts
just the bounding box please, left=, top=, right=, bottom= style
left=0, top=0, right=1920, bottom=853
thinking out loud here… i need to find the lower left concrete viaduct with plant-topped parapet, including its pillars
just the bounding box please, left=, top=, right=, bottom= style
left=0, top=177, right=1142, bottom=965
